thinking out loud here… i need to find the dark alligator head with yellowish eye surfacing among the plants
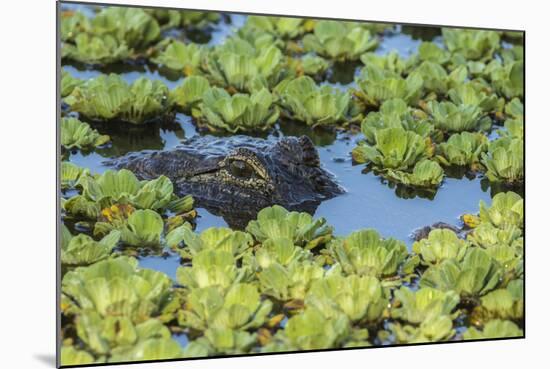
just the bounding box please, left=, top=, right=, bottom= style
left=106, top=135, right=344, bottom=229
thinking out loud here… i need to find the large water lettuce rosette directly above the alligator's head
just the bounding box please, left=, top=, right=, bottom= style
left=196, top=87, right=279, bottom=133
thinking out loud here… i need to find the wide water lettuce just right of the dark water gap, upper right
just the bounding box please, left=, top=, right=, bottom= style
left=355, top=64, right=424, bottom=107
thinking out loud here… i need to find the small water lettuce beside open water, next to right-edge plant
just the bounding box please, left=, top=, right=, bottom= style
left=436, top=132, right=489, bottom=169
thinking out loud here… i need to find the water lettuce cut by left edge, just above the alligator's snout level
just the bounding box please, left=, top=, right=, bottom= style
left=61, top=117, right=111, bottom=149
